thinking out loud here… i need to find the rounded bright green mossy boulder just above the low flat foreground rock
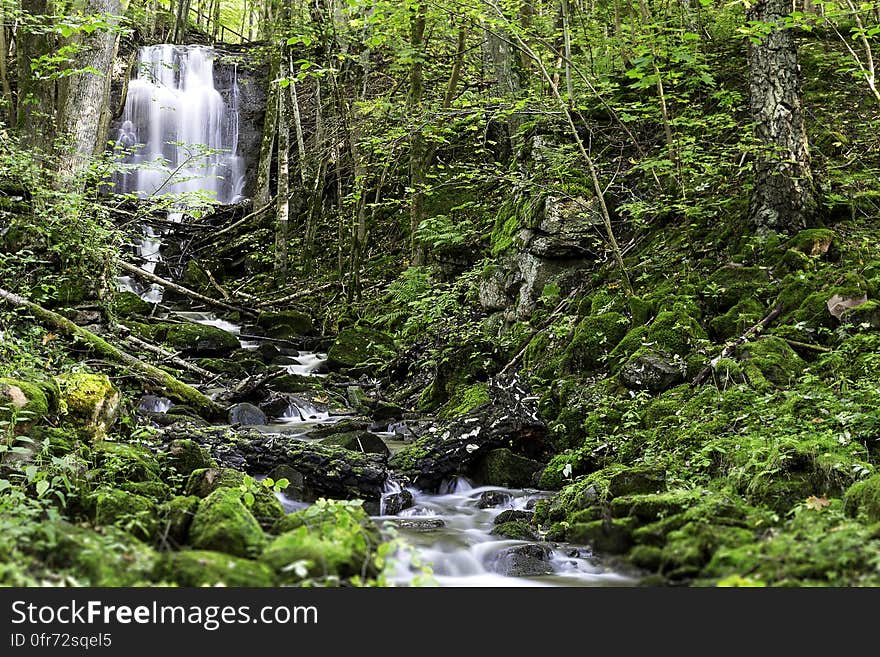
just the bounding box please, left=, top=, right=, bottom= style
left=189, top=488, right=266, bottom=558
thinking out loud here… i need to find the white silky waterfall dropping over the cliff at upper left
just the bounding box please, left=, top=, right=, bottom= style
left=113, top=44, right=244, bottom=205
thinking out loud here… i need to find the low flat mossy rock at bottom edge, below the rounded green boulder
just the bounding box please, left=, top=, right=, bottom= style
left=155, top=550, right=274, bottom=587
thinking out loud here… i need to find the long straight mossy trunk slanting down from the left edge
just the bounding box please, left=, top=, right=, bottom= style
left=0, top=288, right=226, bottom=420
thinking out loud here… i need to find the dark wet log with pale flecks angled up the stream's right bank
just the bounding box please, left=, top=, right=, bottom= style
left=388, top=377, right=547, bottom=490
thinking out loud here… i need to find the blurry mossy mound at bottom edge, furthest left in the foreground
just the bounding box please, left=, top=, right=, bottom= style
left=44, top=521, right=158, bottom=587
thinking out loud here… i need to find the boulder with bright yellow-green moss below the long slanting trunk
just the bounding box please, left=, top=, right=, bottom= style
left=55, top=372, right=120, bottom=437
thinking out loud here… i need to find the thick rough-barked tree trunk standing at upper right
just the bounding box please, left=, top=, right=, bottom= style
left=747, top=0, right=816, bottom=233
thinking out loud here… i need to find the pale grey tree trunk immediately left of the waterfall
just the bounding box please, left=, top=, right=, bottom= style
left=58, top=0, right=122, bottom=189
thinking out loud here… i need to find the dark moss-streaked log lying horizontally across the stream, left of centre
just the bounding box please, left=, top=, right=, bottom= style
left=171, top=425, right=388, bottom=502
